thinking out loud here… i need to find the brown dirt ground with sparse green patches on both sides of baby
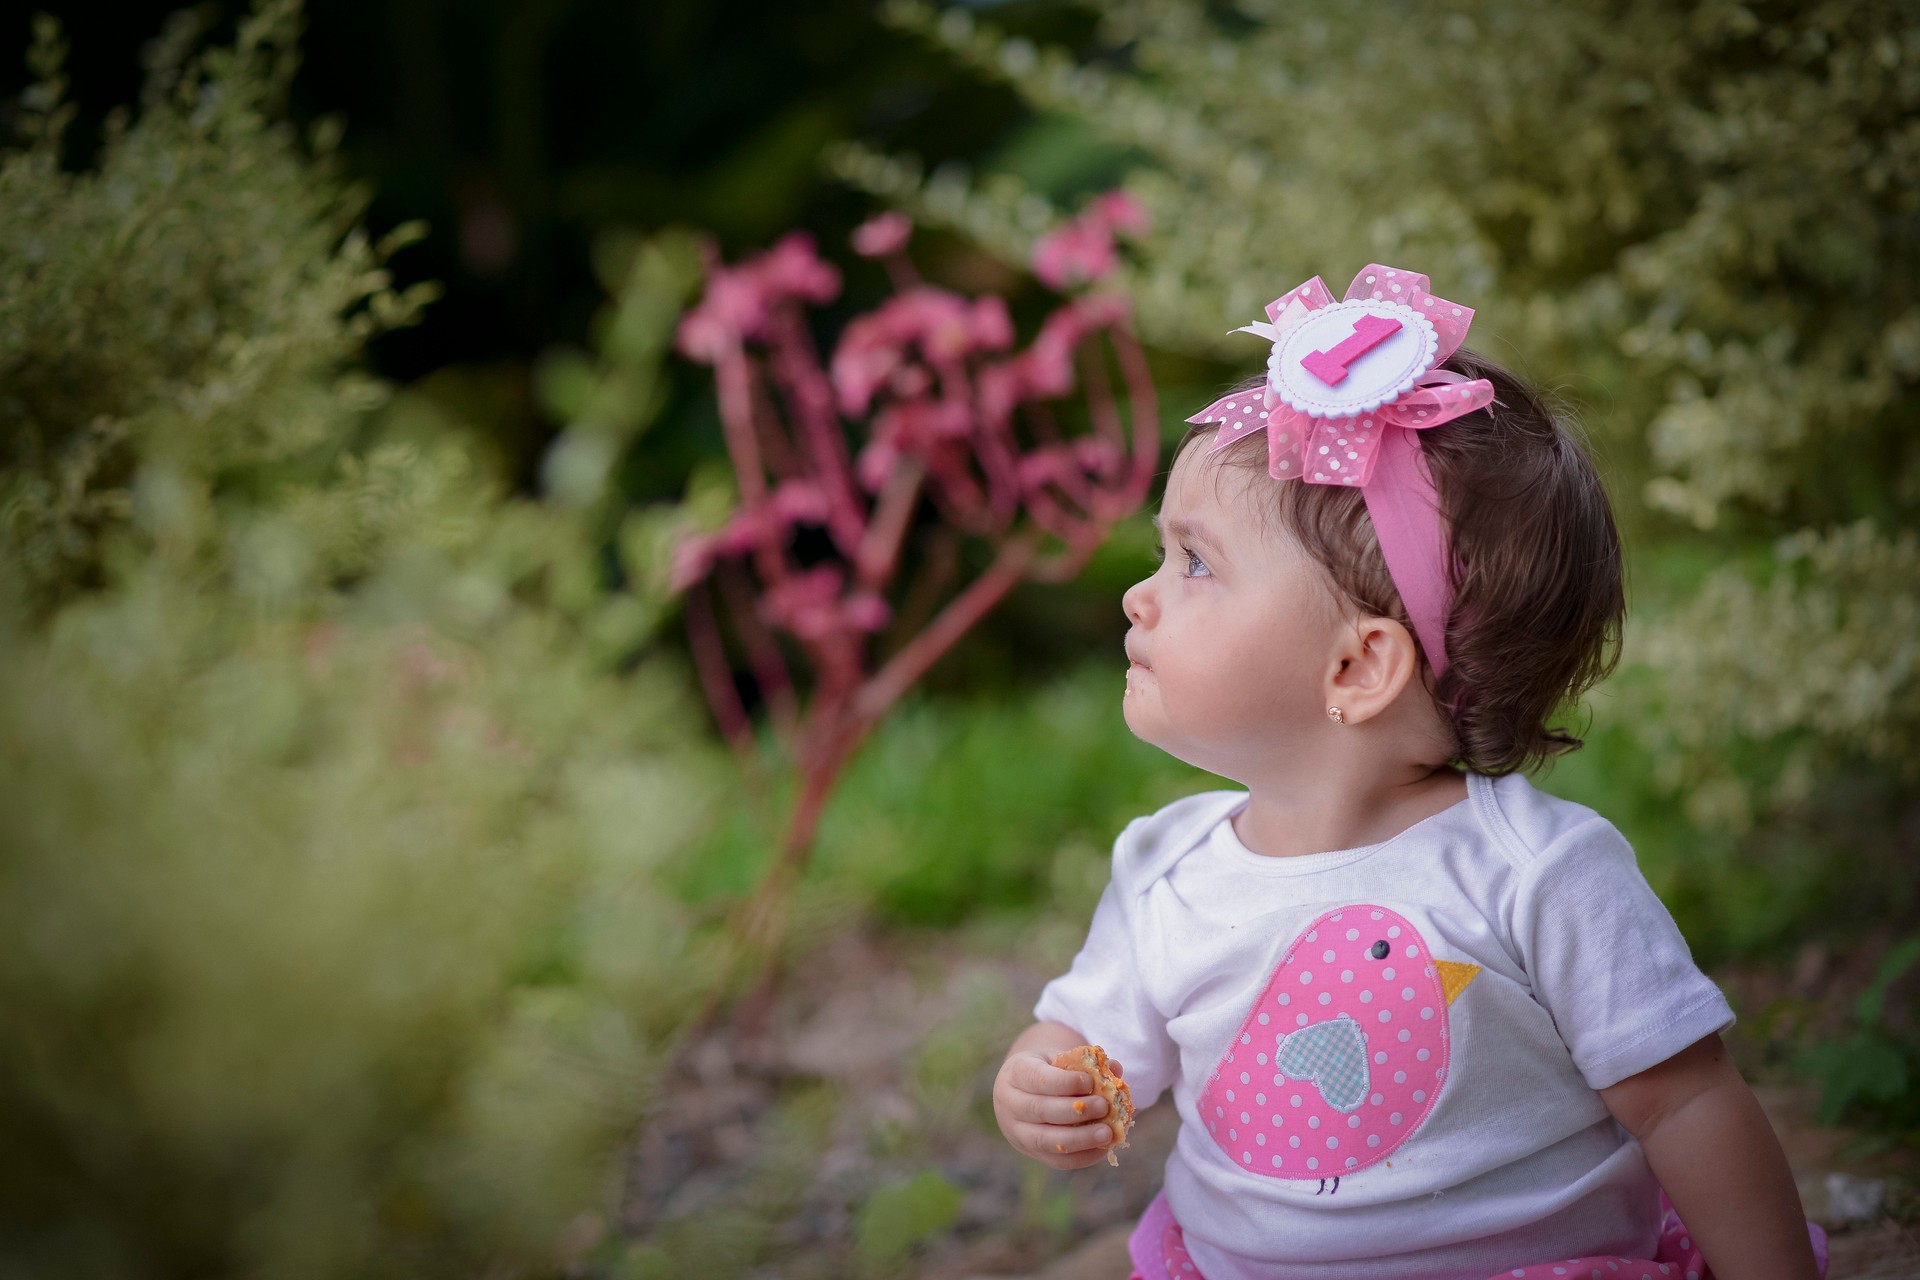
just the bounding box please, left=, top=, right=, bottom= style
left=618, top=931, right=1920, bottom=1280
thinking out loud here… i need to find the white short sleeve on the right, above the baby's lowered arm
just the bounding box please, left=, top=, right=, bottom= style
left=1515, top=819, right=1734, bottom=1090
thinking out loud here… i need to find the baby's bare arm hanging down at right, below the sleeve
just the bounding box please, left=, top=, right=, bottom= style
left=1599, top=1034, right=1818, bottom=1280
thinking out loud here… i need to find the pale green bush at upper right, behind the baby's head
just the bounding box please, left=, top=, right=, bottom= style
left=833, top=0, right=1920, bottom=901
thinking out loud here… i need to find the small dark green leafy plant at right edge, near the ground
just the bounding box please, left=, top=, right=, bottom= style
left=1801, top=936, right=1920, bottom=1134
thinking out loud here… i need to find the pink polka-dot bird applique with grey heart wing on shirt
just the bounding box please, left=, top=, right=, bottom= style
left=1198, top=904, right=1480, bottom=1194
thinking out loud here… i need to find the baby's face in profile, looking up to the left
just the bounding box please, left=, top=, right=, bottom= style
left=1121, top=441, right=1342, bottom=783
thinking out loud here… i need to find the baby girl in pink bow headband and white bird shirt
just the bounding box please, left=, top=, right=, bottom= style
left=995, top=265, right=1824, bottom=1280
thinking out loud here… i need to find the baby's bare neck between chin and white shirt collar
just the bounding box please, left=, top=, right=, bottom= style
left=1233, top=766, right=1467, bottom=858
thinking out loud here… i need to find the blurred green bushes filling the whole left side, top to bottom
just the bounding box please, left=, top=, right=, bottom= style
left=0, top=0, right=724, bottom=1276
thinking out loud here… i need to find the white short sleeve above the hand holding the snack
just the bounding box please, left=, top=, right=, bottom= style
left=1033, top=881, right=1179, bottom=1111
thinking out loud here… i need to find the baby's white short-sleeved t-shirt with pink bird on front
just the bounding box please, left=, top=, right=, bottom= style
left=1033, top=773, right=1734, bottom=1280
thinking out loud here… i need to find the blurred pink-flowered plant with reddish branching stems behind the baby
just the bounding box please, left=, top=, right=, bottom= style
left=672, top=194, right=1160, bottom=959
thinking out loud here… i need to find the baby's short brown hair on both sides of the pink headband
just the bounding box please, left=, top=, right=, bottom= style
left=1175, top=351, right=1626, bottom=773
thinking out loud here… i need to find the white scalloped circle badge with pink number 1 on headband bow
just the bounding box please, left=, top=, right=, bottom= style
left=1267, top=297, right=1440, bottom=418
